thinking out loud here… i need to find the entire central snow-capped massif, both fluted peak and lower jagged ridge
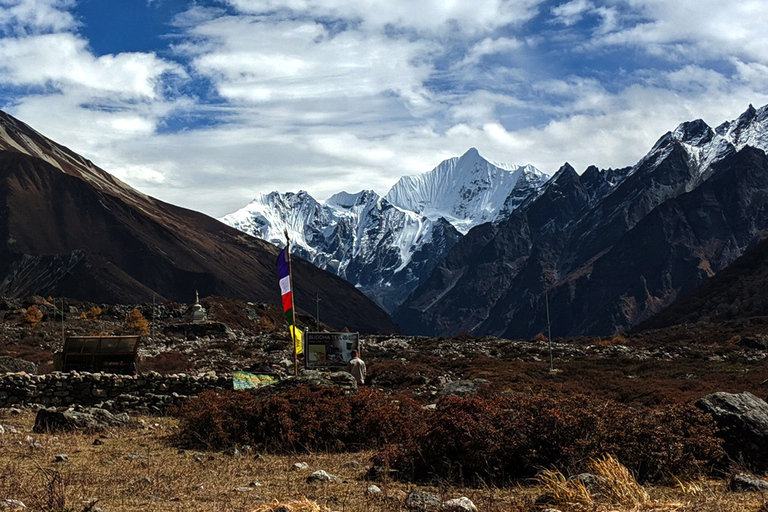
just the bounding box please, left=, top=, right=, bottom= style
left=221, top=148, right=546, bottom=311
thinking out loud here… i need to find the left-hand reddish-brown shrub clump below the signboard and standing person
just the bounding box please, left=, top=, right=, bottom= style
left=180, top=386, right=424, bottom=452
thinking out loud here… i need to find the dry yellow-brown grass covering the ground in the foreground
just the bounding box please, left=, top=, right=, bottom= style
left=0, top=411, right=765, bottom=512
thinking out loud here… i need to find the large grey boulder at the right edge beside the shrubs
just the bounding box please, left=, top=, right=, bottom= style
left=696, top=392, right=768, bottom=472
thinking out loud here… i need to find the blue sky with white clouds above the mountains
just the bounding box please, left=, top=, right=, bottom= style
left=0, top=0, right=768, bottom=216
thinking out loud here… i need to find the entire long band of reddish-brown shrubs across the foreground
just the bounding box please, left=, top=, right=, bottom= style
left=180, top=387, right=723, bottom=485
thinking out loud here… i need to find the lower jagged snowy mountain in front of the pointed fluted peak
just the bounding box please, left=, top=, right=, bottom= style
left=221, top=190, right=461, bottom=310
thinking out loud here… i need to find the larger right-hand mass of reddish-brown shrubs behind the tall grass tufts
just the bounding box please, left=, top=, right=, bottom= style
left=374, top=396, right=723, bottom=484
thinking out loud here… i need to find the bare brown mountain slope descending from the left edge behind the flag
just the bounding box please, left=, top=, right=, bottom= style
left=0, top=112, right=397, bottom=332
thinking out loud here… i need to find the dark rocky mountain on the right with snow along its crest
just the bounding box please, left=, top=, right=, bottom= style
left=394, top=105, right=768, bottom=338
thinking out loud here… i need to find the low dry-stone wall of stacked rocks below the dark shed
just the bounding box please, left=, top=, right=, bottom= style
left=0, top=372, right=232, bottom=413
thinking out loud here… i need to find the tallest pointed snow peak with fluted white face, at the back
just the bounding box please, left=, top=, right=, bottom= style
left=384, top=148, right=549, bottom=234
